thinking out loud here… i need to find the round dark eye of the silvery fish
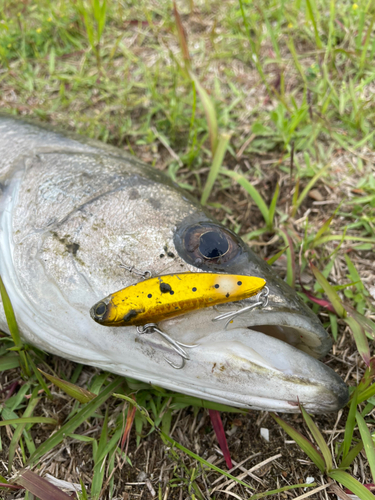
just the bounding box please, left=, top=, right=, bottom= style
left=176, top=222, right=243, bottom=269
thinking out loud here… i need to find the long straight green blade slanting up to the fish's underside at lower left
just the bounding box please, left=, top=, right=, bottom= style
left=29, top=377, right=123, bottom=464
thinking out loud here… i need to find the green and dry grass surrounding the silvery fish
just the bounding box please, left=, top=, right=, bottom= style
left=0, top=0, right=375, bottom=500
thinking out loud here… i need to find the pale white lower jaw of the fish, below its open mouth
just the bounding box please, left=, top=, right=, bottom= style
left=176, top=328, right=348, bottom=413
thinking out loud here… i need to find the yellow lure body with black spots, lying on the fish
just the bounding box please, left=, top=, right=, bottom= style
left=90, top=273, right=266, bottom=326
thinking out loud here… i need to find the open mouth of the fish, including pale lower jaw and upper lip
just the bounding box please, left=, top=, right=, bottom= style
left=159, top=311, right=349, bottom=414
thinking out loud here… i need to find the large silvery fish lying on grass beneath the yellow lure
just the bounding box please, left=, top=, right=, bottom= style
left=0, top=116, right=348, bottom=413
